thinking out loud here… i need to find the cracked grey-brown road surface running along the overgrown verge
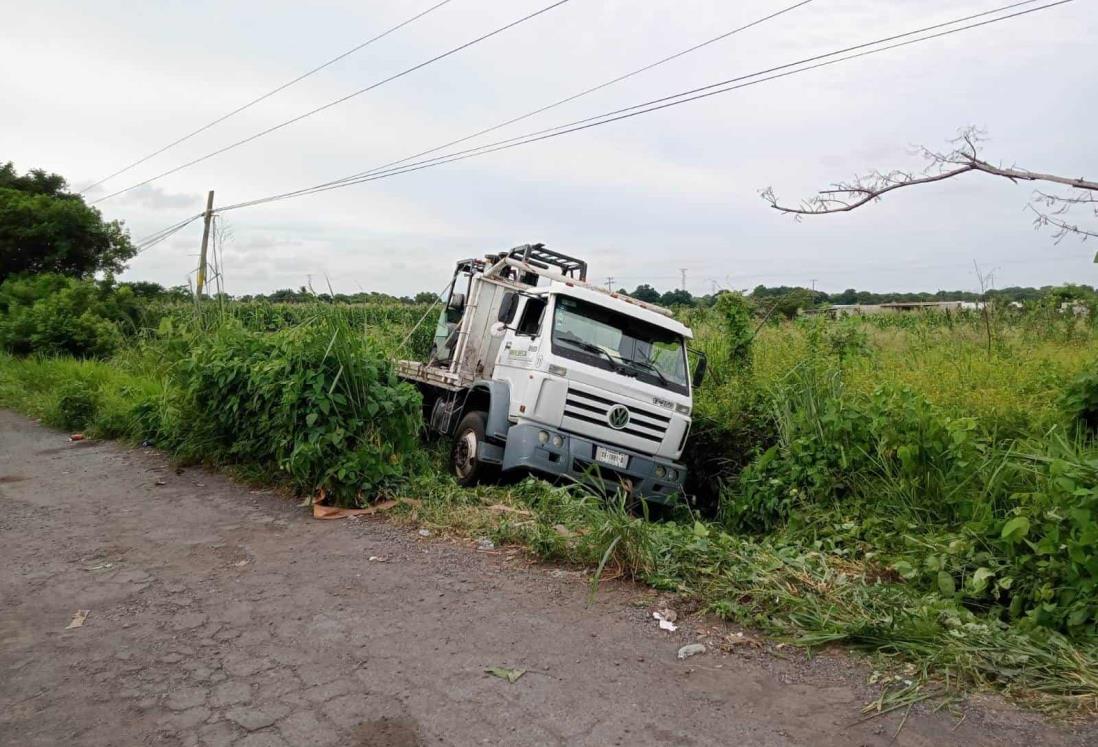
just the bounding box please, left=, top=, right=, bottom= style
left=0, top=412, right=1086, bottom=747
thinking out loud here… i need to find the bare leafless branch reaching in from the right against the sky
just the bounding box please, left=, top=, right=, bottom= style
left=762, top=127, right=1098, bottom=249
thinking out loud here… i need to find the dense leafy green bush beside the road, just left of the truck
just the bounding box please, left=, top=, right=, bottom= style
left=173, top=316, right=421, bottom=504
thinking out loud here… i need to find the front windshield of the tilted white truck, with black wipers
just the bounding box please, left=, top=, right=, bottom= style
left=552, top=296, right=690, bottom=394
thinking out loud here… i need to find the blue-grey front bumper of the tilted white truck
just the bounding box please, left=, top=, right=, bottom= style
left=503, top=423, right=686, bottom=503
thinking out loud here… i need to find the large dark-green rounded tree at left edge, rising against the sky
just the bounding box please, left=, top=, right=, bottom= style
left=0, top=163, right=136, bottom=282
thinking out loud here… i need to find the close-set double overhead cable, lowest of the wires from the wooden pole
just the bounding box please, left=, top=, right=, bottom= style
left=217, top=0, right=1074, bottom=212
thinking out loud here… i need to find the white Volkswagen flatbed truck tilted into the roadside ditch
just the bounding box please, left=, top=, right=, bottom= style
left=397, top=244, right=706, bottom=503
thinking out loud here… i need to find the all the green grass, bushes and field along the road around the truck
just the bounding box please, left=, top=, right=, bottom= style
left=0, top=275, right=1098, bottom=715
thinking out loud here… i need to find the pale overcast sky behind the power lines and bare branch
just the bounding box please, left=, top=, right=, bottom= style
left=0, top=0, right=1098, bottom=294
